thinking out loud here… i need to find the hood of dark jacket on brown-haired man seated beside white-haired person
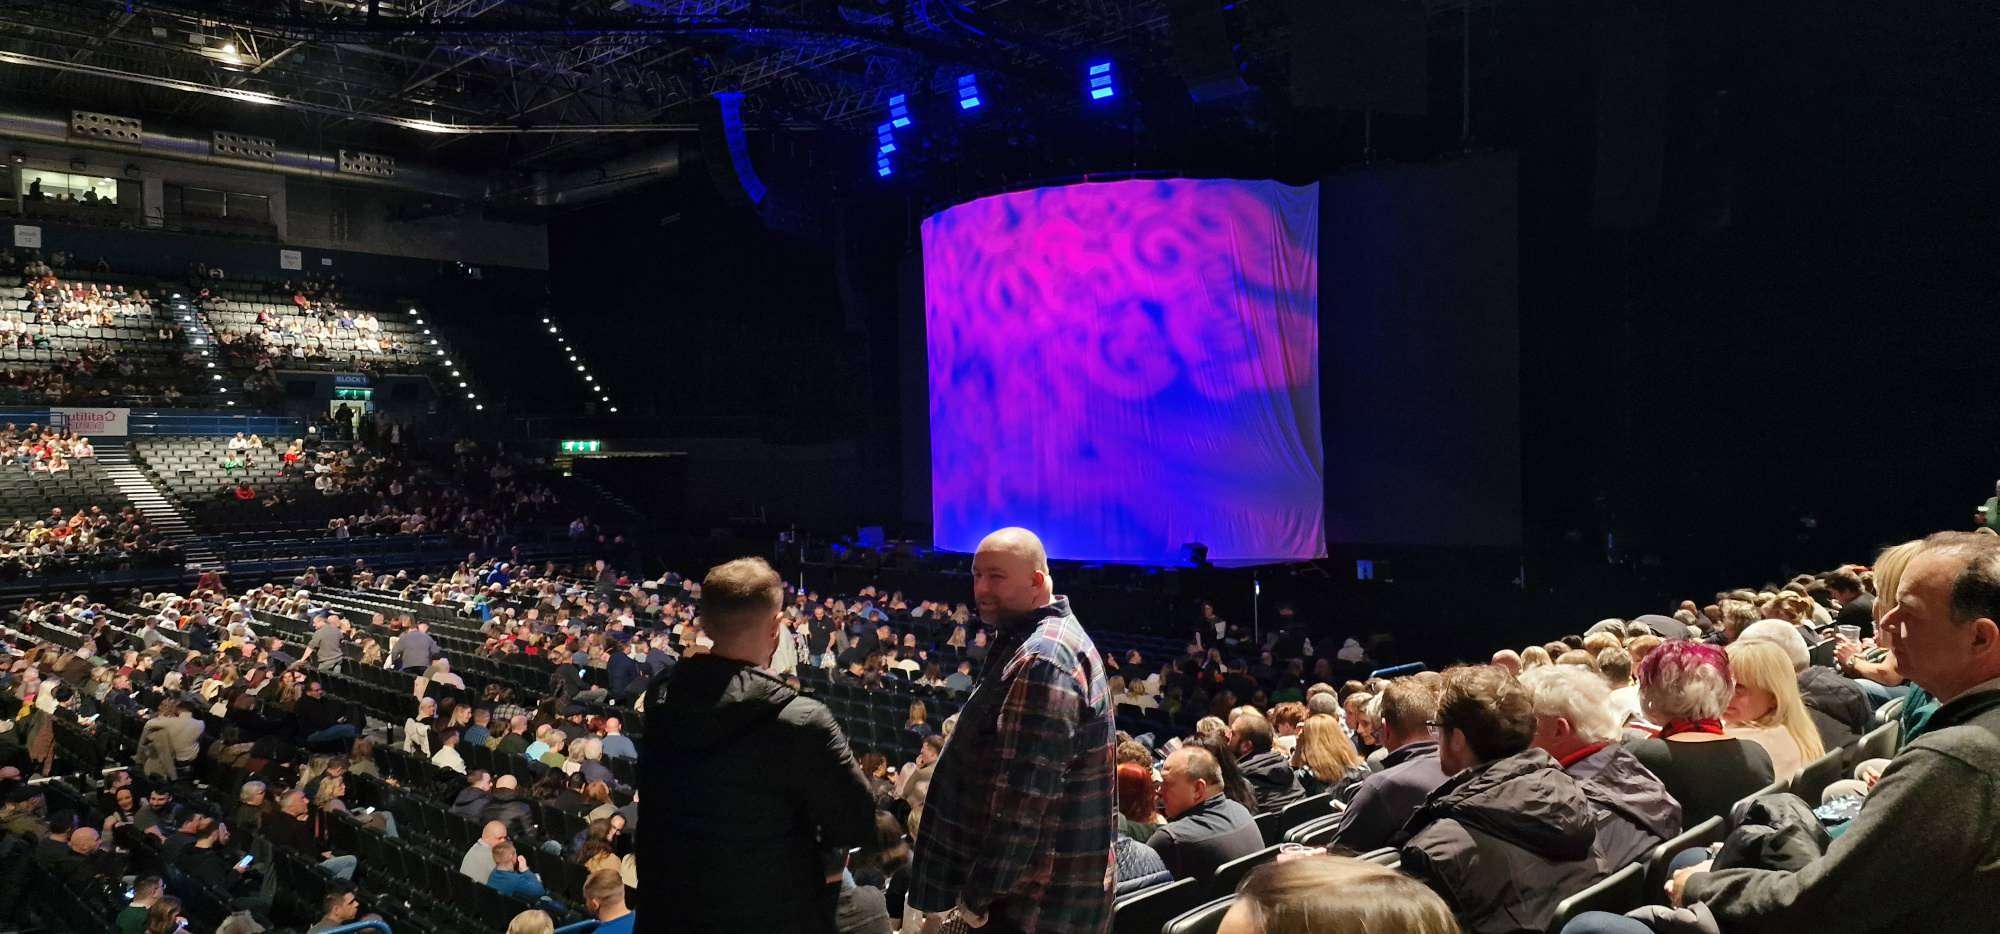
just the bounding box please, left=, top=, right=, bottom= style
left=1408, top=748, right=1598, bottom=860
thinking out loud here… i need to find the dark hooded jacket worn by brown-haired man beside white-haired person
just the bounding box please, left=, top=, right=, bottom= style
left=1398, top=748, right=1606, bottom=934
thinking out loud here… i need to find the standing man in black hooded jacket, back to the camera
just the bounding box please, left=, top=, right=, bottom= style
left=638, top=558, right=874, bottom=934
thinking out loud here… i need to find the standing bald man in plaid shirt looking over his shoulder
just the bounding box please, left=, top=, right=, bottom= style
left=908, top=528, right=1118, bottom=934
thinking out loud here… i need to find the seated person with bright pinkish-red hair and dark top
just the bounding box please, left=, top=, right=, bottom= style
left=1626, top=640, right=1774, bottom=826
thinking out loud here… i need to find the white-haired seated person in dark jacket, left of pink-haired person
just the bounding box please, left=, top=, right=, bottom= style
left=1520, top=666, right=1680, bottom=872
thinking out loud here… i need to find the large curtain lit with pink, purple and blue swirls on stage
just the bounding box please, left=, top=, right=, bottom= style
left=924, top=178, right=1326, bottom=564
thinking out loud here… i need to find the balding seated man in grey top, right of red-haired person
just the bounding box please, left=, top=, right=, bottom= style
left=1146, top=746, right=1264, bottom=878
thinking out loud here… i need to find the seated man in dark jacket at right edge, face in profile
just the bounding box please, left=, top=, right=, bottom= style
left=1564, top=532, right=2000, bottom=934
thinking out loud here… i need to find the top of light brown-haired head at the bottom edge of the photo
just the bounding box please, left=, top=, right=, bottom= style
left=1216, top=856, right=1458, bottom=934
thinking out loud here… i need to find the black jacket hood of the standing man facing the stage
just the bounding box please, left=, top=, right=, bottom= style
left=646, top=654, right=798, bottom=754
